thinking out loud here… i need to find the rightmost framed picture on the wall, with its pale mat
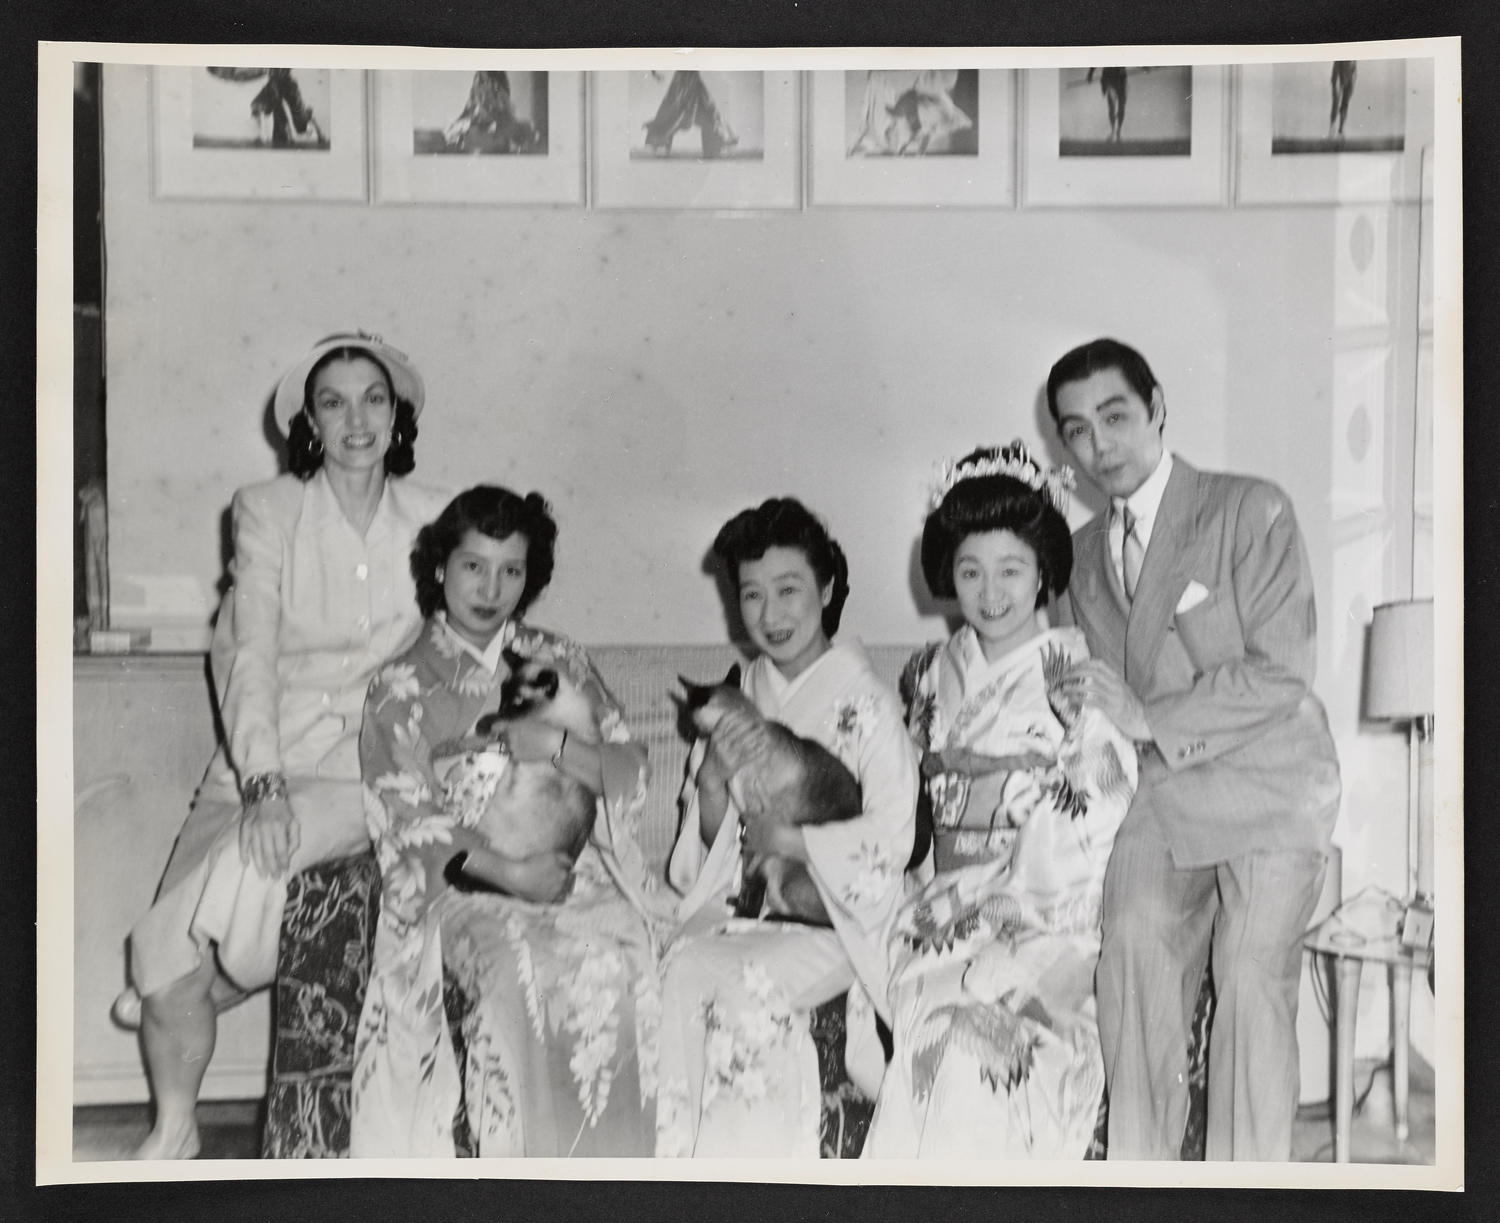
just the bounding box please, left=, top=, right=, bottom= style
left=1235, top=59, right=1433, bottom=204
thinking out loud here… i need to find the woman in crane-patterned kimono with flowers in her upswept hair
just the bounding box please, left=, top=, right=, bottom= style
left=864, top=441, right=1136, bottom=1158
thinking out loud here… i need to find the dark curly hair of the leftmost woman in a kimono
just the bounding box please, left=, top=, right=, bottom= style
left=411, top=485, right=558, bottom=618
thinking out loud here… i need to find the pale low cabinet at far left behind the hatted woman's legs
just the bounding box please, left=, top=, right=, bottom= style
left=74, top=654, right=270, bottom=1104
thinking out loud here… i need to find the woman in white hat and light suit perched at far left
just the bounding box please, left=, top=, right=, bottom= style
left=116, top=332, right=447, bottom=1158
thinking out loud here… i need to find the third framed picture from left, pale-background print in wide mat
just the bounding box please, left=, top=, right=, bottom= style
left=591, top=71, right=801, bottom=210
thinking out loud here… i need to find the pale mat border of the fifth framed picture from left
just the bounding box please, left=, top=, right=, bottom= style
left=1020, top=64, right=1229, bottom=209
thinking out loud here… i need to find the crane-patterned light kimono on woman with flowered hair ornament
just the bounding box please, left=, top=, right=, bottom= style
left=864, top=626, right=1136, bottom=1158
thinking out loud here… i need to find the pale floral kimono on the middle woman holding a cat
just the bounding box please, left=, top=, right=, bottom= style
left=657, top=644, right=918, bottom=1158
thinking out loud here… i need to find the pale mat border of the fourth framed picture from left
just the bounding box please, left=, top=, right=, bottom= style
left=806, top=68, right=1019, bottom=209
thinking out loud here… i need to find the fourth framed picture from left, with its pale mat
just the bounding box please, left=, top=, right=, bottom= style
left=809, top=68, right=1016, bottom=206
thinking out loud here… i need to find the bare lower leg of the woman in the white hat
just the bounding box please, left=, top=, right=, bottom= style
left=135, top=950, right=218, bottom=1160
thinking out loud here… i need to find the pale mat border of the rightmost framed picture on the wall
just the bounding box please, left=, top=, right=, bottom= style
left=1235, top=56, right=1436, bottom=204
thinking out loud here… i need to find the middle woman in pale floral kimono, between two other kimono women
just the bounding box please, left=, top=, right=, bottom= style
left=657, top=498, right=918, bottom=1158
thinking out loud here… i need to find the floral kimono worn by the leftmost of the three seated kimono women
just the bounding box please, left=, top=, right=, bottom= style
left=351, top=617, right=665, bottom=1157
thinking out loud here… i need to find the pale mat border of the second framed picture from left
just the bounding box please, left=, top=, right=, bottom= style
left=369, top=65, right=587, bottom=207
